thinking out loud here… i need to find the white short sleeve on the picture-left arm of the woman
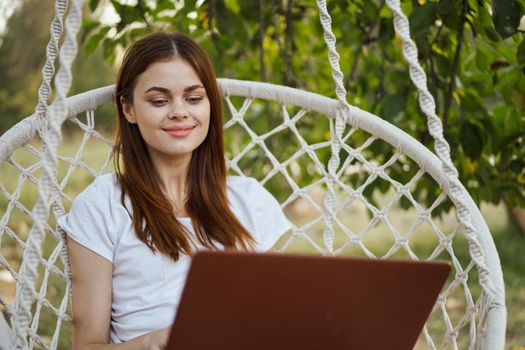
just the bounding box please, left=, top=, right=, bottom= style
left=58, top=178, right=122, bottom=262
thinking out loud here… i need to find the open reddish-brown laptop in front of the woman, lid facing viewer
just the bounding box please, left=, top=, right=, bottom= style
left=167, top=251, right=451, bottom=350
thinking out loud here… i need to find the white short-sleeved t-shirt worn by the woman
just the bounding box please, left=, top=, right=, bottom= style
left=58, top=174, right=290, bottom=343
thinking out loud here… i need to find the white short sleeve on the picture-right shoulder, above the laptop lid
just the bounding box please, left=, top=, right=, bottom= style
left=249, top=179, right=291, bottom=252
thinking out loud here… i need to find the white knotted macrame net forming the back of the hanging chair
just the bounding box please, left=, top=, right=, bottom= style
left=0, top=82, right=504, bottom=349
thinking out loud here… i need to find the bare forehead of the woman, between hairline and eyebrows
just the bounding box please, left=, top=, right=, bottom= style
left=135, top=58, right=203, bottom=93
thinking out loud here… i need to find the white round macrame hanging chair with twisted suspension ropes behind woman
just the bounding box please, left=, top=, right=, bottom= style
left=0, top=0, right=506, bottom=350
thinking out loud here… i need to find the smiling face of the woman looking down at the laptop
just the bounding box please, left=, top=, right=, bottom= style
left=121, top=58, right=210, bottom=161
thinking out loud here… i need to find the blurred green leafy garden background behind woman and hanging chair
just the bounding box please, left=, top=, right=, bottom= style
left=0, top=0, right=525, bottom=349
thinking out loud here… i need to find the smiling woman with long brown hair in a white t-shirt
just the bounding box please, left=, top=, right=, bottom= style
left=59, top=33, right=290, bottom=349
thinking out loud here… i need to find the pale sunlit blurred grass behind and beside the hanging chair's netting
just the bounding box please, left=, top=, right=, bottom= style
left=0, top=133, right=525, bottom=350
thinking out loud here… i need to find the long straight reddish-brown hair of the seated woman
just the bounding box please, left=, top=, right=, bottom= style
left=113, top=32, right=254, bottom=260
